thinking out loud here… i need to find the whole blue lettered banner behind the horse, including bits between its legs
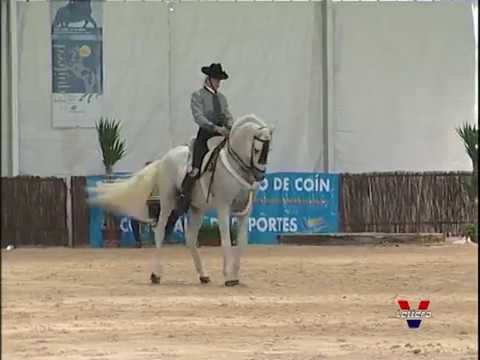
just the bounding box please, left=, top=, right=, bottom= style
left=87, top=172, right=340, bottom=247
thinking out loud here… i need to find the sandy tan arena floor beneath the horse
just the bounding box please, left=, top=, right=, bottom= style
left=2, top=244, right=478, bottom=360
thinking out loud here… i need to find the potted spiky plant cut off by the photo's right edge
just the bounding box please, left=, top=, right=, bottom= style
left=456, top=124, right=478, bottom=242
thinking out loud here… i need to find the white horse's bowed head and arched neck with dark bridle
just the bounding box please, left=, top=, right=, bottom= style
left=229, top=115, right=273, bottom=181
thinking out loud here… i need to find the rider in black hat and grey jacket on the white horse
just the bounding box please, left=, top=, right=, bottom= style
left=178, top=63, right=233, bottom=214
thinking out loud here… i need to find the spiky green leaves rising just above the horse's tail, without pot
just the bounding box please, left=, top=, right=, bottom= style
left=96, top=117, right=126, bottom=177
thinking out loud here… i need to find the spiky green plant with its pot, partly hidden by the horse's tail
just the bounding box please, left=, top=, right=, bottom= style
left=95, top=117, right=126, bottom=247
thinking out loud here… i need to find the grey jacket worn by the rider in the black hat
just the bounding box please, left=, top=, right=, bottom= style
left=190, top=88, right=233, bottom=132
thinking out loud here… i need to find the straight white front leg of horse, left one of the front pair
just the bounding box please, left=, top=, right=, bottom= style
left=218, top=206, right=239, bottom=286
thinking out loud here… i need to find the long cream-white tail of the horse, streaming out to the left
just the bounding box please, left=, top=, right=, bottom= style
left=88, top=159, right=162, bottom=222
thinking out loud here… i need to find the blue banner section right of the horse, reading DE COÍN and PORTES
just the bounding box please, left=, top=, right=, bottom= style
left=242, top=172, right=339, bottom=244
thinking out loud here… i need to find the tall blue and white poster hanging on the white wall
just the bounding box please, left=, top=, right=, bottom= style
left=50, top=0, right=103, bottom=127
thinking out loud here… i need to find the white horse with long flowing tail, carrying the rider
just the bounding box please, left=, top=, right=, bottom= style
left=88, top=115, right=273, bottom=286
